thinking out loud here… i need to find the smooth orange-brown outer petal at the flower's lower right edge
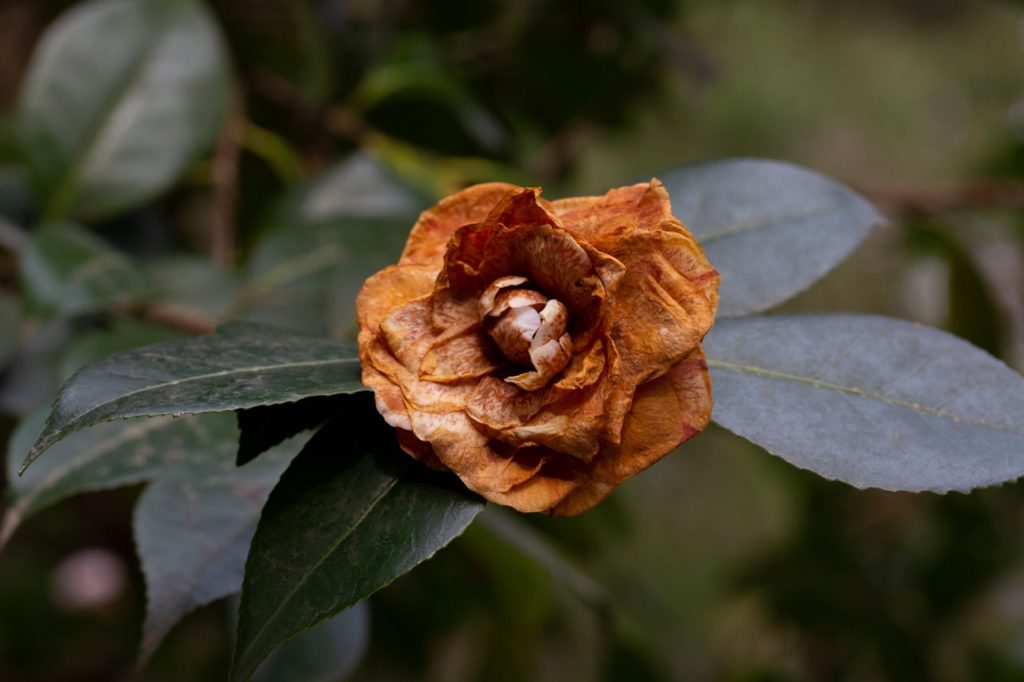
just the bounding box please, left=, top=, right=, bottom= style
left=553, top=348, right=712, bottom=516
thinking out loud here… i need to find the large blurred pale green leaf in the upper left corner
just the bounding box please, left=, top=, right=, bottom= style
left=17, top=0, right=229, bottom=220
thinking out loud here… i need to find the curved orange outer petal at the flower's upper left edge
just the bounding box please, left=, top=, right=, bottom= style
left=399, top=182, right=521, bottom=267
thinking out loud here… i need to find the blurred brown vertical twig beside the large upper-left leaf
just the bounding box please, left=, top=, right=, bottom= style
left=210, top=89, right=246, bottom=269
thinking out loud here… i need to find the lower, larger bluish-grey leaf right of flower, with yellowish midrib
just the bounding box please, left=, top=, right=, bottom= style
left=705, top=314, right=1024, bottom=492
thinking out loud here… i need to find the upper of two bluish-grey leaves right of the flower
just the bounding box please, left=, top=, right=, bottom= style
left=662, top=159, right=883, bottom=317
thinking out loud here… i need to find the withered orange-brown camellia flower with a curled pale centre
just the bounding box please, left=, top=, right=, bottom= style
left=357, top=180, right=719, bottom=514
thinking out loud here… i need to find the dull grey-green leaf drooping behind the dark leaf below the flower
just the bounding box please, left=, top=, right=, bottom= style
left=134, top=425, right=298, bottom=662
